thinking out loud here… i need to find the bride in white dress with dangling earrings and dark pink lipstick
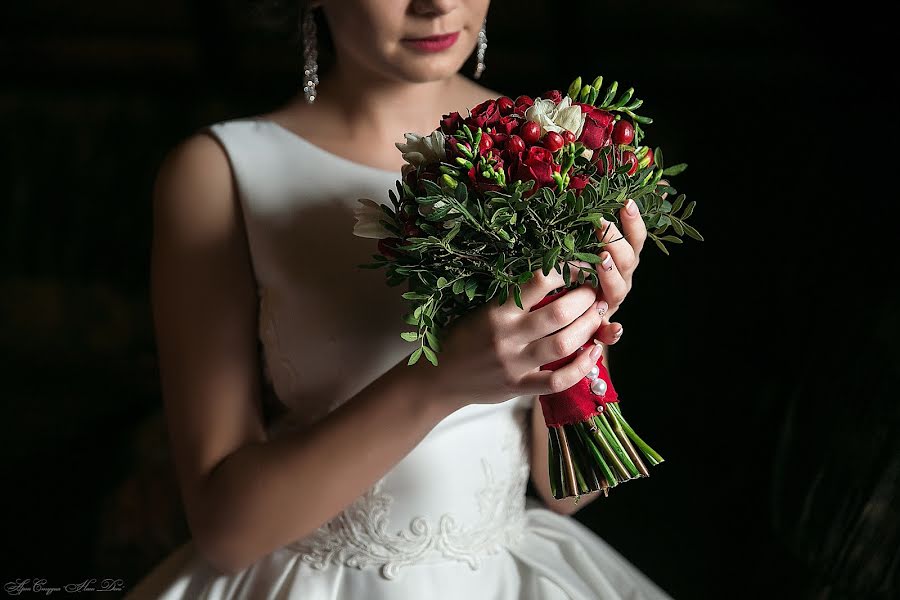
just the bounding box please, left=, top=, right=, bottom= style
left=128, top=0, right=669, bottom=600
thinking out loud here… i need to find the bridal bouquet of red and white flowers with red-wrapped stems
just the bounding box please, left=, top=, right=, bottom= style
left=354, top=77, right=703, bottom=502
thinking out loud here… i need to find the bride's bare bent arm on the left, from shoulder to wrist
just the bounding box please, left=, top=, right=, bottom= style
left=151, top=134, right=456, bottom=573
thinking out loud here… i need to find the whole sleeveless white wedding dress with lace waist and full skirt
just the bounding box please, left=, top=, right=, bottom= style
left=126, top=118, right=670, bottom=600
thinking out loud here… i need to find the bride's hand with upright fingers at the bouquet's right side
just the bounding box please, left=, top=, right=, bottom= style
left=595, top=199, right=647, bottom=344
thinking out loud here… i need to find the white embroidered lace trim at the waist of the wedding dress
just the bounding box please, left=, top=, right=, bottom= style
left=286, top=430, right=530, bottom=579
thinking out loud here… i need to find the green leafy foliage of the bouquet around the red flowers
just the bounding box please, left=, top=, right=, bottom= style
left=360, top=77, right=703, bottom=365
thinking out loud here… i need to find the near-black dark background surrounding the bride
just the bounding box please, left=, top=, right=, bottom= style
left=0, top=0, right=900, bottom=598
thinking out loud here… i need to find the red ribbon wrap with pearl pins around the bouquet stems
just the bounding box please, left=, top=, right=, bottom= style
left=531, top=289, right=619, bottom=426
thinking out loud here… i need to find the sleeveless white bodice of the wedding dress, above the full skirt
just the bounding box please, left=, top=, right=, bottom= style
left=209, top=118, right=532, bottom=578
